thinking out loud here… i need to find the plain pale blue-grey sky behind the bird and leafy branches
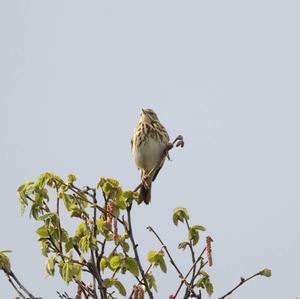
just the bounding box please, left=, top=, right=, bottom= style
left=0, top=0, right=300, bottom=299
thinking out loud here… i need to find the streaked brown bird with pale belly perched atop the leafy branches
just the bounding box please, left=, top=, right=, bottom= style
left=131, top=109, right=170, bottom=204
